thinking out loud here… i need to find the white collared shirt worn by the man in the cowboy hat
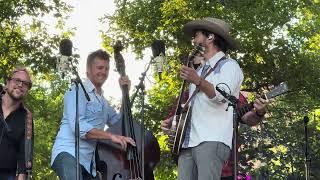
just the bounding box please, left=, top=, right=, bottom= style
left=187, top=51, right=243, bottom=148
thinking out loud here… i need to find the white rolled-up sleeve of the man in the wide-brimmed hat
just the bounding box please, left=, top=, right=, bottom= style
left=208, top=60, right=243, bottom=103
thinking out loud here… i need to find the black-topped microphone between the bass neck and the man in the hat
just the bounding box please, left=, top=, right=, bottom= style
left=151, top=40, right=166, bottom=80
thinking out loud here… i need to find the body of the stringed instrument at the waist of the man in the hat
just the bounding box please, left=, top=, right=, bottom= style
left=169, top=106, right=191, bottom=155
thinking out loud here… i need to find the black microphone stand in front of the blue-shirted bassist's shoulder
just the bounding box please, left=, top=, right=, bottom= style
left=70, top=60, right=90, bottom=180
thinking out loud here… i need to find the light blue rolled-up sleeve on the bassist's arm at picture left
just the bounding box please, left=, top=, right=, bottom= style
left=63, top=87, right=94, bottom=139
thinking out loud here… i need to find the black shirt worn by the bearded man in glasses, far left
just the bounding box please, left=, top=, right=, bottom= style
left=0, top=95, right=27, bottom=174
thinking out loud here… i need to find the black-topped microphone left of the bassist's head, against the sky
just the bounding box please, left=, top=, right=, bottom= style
left=57, top=39, right=72, bottom=78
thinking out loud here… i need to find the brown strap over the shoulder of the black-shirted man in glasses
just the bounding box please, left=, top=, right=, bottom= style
left=24, top=107, right=33, bottom=176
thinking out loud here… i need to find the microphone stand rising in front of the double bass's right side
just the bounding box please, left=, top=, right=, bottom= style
left=130, top=58, right=153, bottom=180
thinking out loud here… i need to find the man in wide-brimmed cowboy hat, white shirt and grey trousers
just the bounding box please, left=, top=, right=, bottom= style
left=174, top=17, right=243, bottom=180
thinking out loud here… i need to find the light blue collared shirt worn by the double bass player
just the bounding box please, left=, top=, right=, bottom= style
left=51, top=79, right=120, bottom=176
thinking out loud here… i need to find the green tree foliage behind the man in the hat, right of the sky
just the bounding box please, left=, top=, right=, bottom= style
left=104, top=0, right=320, bottom=179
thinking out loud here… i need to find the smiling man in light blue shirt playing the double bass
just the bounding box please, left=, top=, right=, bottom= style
left=51, top=50, right=135, bottom=180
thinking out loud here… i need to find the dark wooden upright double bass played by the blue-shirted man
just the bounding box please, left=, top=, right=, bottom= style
left=97, top=42, right=160, bottom=180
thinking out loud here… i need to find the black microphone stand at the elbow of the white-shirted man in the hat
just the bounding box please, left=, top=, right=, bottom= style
left=216, top=84, right=239, bottom=180
